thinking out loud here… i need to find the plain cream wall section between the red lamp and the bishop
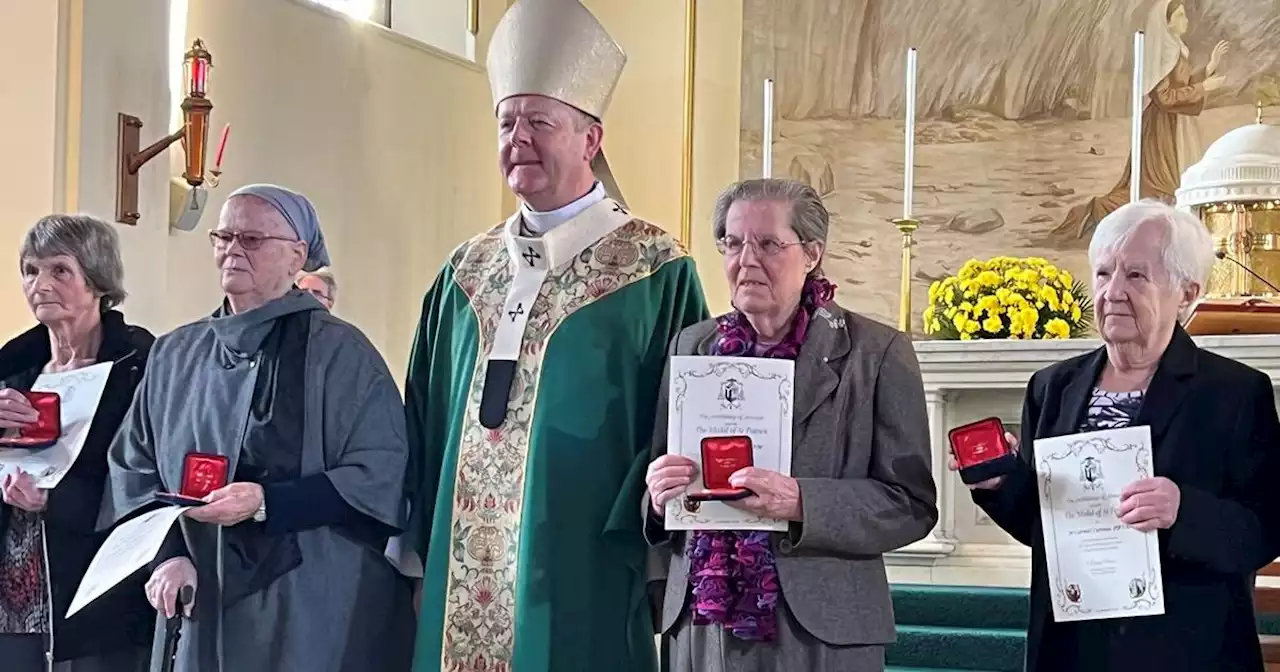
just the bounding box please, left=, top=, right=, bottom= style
left=169, top=0, right=500, bottom=375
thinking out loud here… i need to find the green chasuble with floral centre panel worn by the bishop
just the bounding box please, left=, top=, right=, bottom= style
left=404, top=198, right=708, bottom=672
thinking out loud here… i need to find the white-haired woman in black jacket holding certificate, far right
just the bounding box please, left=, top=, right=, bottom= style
left=952, top=201, right=1280, bottom=672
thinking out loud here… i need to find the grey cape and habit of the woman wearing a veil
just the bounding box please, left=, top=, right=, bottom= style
left=102, top=289, right=412, bottom=672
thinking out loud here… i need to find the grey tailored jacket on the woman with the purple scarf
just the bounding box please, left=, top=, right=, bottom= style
left=641, top=303, right=938, bottom=659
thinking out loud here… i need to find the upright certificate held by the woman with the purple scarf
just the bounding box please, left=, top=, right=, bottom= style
left=666, top=356, right=795, bottom=531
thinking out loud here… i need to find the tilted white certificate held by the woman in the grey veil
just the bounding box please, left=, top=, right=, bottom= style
left=65, top=507, right=187, bottom=618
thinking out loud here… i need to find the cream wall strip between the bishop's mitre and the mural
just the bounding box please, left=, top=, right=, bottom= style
left=584, top=0, right=742, bottom=312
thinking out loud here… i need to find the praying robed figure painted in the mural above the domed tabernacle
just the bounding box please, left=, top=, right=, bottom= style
left=1052, top=0, right=1228, bottom=241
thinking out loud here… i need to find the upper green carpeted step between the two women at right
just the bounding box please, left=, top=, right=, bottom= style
left=890, top=584, right=1028, bottom=632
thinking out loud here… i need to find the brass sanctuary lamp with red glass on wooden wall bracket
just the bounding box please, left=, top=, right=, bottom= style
left=115, top=38, right=214, bottom=224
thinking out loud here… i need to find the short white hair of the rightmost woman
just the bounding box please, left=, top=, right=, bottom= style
left=1089, top=198, right=1215, bottom=321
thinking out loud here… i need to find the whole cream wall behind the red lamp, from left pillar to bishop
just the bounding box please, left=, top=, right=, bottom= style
left=56, top=0, right=500, bottom=376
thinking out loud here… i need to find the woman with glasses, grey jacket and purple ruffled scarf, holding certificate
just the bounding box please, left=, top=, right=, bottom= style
left=643, top=179, right=937, bottom=672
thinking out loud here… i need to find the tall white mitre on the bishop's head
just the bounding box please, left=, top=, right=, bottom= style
left=485, top=0, right=627, bottom=205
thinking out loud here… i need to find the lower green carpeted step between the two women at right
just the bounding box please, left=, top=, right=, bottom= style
left=884, top=625, right=1027, bottom=672
